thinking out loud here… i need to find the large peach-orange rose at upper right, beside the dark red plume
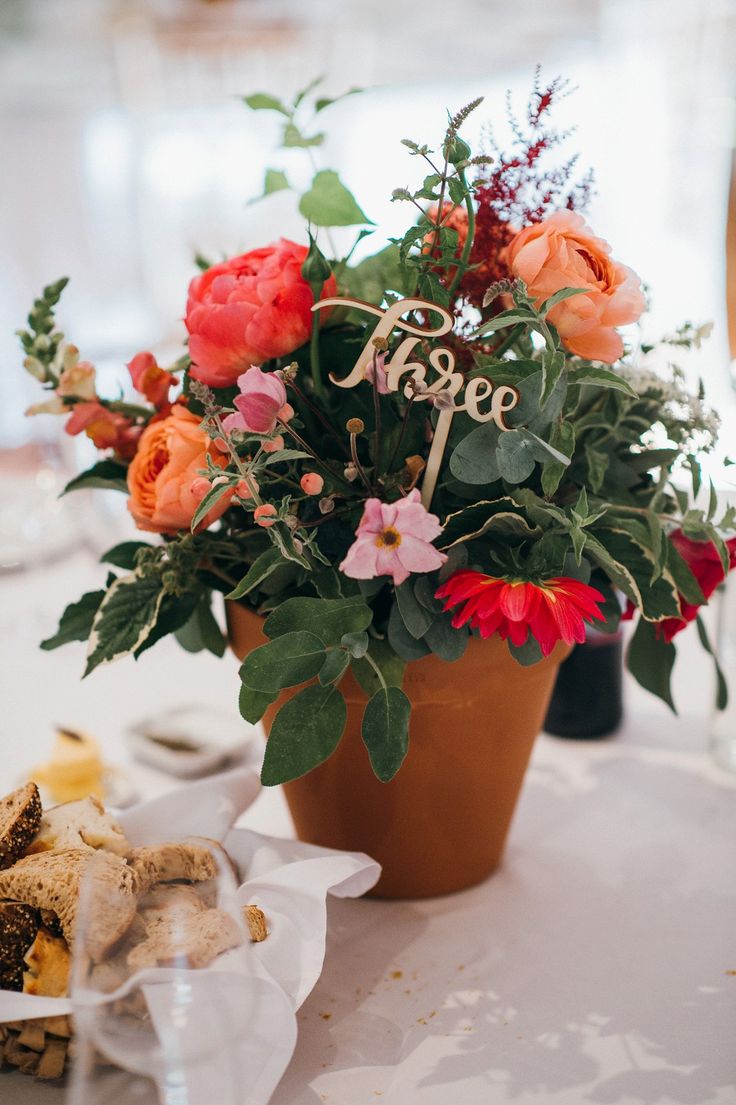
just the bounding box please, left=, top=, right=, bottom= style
left=507, top=211, right=644, bottom=365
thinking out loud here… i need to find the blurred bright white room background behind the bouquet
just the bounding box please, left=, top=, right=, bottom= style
left=0, top=0, right=736, bottom=782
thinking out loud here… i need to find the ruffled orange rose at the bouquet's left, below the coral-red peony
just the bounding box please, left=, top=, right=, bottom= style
left=128, top=407, right=232, bottom=534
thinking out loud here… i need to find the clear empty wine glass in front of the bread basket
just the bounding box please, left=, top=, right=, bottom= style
left=69, top=838, right=256, bottom=1105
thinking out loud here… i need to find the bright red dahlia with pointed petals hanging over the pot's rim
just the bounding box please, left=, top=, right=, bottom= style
left=435, top=569, right=604, bottom=656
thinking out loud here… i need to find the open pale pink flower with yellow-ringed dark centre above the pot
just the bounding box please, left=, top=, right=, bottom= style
left=340, top=488, right=448, bottom=583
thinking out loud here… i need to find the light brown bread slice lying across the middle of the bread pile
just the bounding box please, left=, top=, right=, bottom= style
left=0, top=849, right=137, bottom=962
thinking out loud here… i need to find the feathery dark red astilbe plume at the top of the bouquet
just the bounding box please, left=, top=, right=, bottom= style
left=461, top=69, right=592, bottom=307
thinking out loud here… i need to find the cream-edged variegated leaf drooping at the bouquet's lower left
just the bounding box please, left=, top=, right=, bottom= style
left=84, top=575, right=164, bottom=675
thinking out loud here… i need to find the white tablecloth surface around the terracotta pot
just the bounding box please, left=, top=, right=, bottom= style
left=0, top=543, right=736, bottom=1105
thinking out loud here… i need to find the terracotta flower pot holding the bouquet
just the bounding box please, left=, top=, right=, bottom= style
left=227, top=603, right=570, bottom=897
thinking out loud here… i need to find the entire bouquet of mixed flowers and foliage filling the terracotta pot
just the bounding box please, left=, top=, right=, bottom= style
left=20, top=80, right=736, bottom=783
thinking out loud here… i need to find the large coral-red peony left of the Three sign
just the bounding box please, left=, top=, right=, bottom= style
left=186, top=238, right=336, bottom=388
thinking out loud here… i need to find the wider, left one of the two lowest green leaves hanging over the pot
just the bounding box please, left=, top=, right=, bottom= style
left=261, top=683, right=349, bottom=787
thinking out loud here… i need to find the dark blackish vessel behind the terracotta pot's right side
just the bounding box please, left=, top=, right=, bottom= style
left=544, top=633, right=623, bottom=739
